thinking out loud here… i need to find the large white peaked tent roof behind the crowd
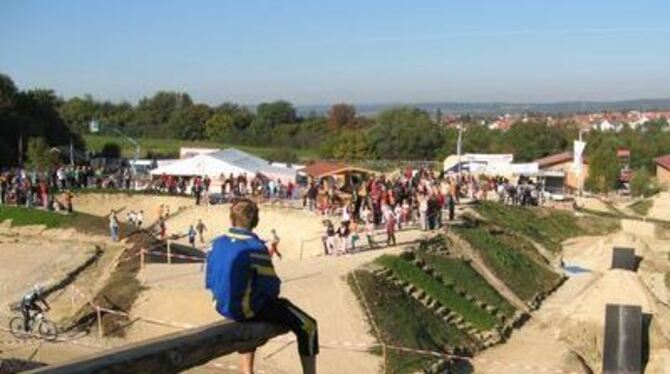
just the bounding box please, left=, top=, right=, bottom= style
left=151, top=148, right=296, bottom=181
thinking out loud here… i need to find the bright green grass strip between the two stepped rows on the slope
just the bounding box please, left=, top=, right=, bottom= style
left=375, top=255, right=496, bottom=331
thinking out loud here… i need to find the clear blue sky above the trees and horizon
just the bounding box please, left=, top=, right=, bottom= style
left=0, top=0, right=670, bottom=104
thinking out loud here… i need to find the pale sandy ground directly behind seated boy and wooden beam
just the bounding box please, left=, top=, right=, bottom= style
left=128, top=235, right=420, bottom=373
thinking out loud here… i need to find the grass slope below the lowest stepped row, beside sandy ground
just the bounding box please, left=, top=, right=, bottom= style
left=347, top=270, right=474, bottom=373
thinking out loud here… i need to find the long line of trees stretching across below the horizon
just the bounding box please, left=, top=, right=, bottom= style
left=0, top=74, right=670, bottom=193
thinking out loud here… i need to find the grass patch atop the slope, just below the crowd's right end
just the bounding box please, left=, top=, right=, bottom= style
left=476, top=201, right=615, bottom=252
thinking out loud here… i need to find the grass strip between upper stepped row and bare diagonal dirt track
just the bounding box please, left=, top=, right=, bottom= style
left=418, top=252, right=515, bottom=316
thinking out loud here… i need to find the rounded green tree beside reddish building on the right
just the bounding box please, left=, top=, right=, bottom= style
left=586, top=139, right=621, bottom=193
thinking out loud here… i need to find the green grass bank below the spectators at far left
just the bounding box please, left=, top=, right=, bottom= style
left=0, top=205, right=107, bottom=234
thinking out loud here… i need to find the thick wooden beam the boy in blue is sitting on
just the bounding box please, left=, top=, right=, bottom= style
left=31, top=320, right=288, bottom=374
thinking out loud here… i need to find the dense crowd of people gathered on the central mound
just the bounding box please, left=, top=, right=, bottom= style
left=312, top=168, right=542, bottom=255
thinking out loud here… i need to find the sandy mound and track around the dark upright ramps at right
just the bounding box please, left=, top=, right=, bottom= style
left=474, top=226, right=668, bottom=373
